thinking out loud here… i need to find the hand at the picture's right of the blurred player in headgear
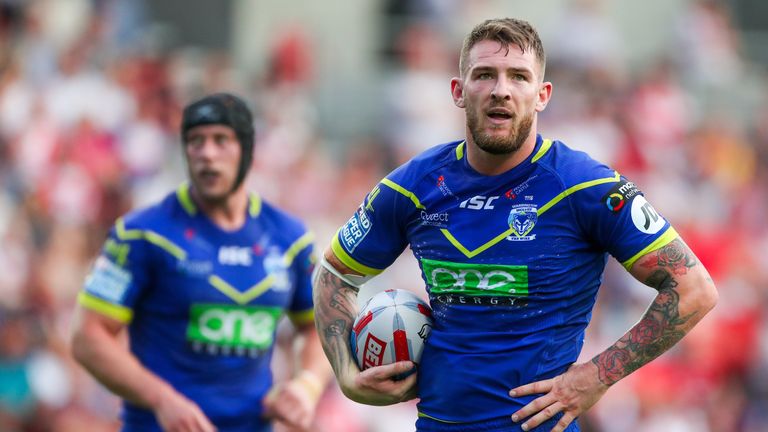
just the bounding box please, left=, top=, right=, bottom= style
left=264, top=374, right=324, bottom=431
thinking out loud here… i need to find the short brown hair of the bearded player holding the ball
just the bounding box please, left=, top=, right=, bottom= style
left=459, top=18, right=547, bottom=77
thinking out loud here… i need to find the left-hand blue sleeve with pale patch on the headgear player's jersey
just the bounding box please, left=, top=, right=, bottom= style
left=78, top=218, right=150, bottom=324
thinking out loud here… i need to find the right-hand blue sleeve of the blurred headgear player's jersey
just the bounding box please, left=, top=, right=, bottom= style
left=286, top=232, right=316, bottom=326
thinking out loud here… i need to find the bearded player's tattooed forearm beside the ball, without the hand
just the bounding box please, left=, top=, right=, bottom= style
left=313, top=268, right=358, bottom=376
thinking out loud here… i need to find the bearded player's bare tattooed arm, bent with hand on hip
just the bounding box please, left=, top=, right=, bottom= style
left=510, top=238, right=717, bottom=432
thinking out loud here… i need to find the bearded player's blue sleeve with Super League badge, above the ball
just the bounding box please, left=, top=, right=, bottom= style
left=331, top=178, right=418, bottom=276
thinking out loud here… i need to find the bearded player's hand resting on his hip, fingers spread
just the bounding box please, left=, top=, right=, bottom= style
left=509, top=362, right=608, bottom=432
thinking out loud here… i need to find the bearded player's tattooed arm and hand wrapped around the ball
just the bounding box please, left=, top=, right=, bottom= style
left=313, top=249, right=416, bottom=405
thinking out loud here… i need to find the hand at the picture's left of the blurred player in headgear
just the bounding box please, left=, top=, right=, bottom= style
left=155, top=390, right=216, bottom=432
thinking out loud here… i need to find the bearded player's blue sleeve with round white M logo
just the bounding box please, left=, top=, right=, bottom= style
left=572, top=170, right=678, bottom=270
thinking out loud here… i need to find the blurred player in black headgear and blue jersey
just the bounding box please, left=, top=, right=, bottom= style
left=72, top=93, right=330, bottom=432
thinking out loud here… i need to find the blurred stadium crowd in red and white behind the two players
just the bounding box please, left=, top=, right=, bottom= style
left=0, top=0, right=768, bottom=432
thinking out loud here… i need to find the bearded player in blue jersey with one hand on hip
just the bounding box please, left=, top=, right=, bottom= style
left=314, top=18, right=718, bottom=432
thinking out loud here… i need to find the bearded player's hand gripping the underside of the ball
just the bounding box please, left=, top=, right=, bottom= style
left=339, top=361, right=416, bottom=405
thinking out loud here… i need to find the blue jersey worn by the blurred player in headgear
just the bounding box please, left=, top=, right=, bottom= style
left=78, top=184, right=314, bottom=431
